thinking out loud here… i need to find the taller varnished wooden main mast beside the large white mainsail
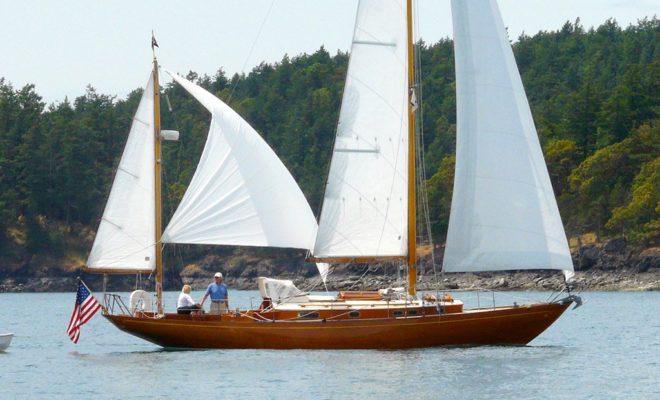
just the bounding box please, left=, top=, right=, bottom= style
left=406, top=0, right=417, bottom=296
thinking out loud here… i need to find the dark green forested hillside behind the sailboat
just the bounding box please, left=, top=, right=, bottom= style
left=0, top=18, right=660, bottom=272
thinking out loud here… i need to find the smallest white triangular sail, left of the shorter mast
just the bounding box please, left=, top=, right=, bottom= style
left=86, top=75, right=156, bottom=272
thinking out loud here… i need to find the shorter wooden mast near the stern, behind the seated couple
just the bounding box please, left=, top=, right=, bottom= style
left=151, top=33, right=163, bottom=315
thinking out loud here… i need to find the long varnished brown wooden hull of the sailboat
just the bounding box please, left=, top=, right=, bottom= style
left=105, top=301, right=572, bottom=349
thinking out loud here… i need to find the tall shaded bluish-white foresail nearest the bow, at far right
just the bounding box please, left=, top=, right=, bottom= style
left=443, top=0, right=573, bottom=278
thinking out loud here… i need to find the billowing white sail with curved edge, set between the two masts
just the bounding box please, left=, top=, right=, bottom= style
left=162, top=71, right=318, bottom=250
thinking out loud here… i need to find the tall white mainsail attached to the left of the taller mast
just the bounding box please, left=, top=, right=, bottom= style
left=314, top=0, right=408, bottom=258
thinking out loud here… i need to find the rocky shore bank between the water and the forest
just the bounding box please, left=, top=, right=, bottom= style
left=0, top=239, right=660, bottom=293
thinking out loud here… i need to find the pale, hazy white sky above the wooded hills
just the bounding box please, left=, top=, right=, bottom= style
left=0, top=0, right=660, bottom=104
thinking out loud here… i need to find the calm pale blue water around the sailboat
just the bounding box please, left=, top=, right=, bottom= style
left=0, top=291, right=660, bottom=399
